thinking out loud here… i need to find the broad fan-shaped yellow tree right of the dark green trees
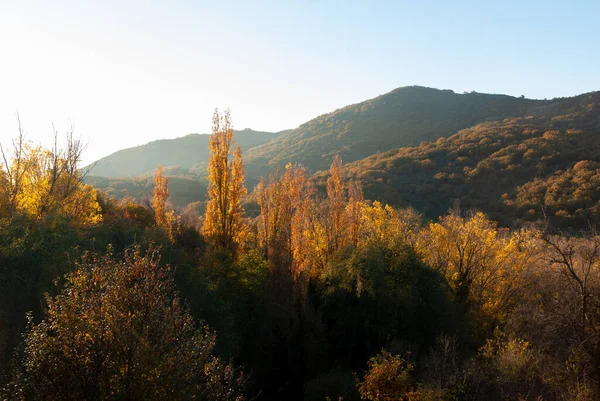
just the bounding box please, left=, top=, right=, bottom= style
left=417, top=213, right=538, bottom=329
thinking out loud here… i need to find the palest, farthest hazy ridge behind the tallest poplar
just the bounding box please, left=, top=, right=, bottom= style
left=85, top=129, right=278, bottom=177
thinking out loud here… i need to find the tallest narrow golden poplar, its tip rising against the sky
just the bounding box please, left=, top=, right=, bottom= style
left=202, top=110, right=246, bottom=250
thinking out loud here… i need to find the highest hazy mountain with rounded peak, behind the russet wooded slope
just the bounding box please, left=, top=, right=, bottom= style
left=245, top=86, right=552, bottom=174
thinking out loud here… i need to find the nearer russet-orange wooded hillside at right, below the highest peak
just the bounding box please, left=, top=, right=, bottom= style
left=328, top=92, right=600, bottom=228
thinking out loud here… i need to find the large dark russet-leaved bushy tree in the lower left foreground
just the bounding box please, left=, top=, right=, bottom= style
left=5, top=249, right=243, bottom=401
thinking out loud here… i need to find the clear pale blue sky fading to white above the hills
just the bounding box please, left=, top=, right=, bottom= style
left=0, top=0, right=600, bottom=164
